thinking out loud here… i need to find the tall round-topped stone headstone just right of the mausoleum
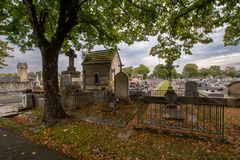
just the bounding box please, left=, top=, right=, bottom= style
left=114, top=72, right=129, bottom=100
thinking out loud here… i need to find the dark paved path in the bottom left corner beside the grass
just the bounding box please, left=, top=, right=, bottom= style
left=0, top=128, right=71, bottom=160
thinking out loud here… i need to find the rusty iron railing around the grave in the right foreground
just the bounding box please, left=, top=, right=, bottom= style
left=138, top=97, right=224, bottom=138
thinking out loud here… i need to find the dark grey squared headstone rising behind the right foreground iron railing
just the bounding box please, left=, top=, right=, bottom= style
left=185, top=81, right=198, bottom=97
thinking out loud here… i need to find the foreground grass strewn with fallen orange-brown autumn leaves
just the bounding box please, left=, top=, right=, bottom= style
left=0, top=108, right=240, bottom=160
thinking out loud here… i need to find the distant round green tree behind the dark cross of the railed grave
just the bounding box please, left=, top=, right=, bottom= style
left=153, top=64, right=177, bottom=79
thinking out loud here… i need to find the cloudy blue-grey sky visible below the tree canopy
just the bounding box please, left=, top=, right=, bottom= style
left=0, top=28, right=240, bottom=73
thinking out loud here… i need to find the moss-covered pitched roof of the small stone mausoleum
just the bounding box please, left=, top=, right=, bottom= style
left=82, top=49, right=117, bottom=64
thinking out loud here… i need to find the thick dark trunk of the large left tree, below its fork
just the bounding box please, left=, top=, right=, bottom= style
left=41, top=50, right=66, bottom=123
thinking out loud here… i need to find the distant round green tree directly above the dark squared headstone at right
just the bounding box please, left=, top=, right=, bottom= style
left=183, top=63, right=198, bottom=78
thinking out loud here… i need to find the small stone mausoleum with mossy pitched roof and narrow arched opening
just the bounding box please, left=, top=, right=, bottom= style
left=82, top=49, right=122, bottom=93
